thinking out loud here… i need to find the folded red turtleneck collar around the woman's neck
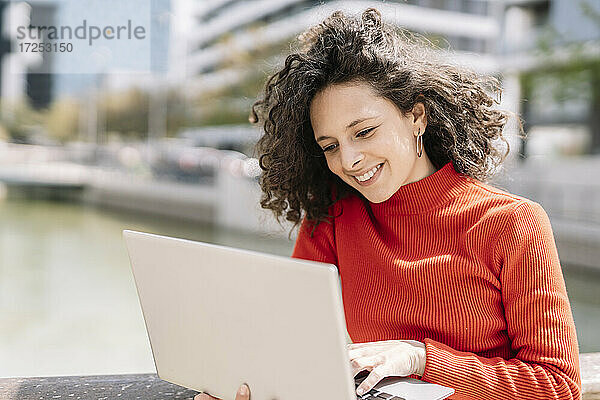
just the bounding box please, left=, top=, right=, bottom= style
left=369, top=162, right=472, bottom=216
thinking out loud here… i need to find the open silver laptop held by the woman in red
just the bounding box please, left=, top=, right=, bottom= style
left=123, top=230, right=454, bottom=400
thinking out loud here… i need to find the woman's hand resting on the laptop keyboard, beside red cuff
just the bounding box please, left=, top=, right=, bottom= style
left=348, top=340, right=426, bottom=396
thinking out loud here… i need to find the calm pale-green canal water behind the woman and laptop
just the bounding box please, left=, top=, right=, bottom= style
left=0, top=200, right=600, bottom=377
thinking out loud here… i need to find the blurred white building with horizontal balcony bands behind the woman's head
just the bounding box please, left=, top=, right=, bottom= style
left=186, top=0, right=500, bottom=106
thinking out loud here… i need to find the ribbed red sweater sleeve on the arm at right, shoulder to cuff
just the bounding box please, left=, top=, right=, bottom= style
left=422, top=201, right=581, bottom=400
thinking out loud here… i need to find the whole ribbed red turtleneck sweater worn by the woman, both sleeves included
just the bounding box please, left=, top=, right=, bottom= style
left=292, top=163, right=581, bottom=400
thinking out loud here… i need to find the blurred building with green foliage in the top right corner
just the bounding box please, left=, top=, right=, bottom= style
left=498, top=0, right=600, bottom=157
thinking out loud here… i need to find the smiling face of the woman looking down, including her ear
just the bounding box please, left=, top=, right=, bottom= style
left=310, top=83, right=436, bottom=203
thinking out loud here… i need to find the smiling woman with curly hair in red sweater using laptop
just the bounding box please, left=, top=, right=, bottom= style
left=197, top=9, right=581, bottom=400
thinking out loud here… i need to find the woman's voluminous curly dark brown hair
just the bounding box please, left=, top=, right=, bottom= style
left=249, top=8, right=522, bottom=234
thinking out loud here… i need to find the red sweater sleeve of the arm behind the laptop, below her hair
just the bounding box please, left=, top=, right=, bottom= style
left=292, top=212, right=338, bottom=266
